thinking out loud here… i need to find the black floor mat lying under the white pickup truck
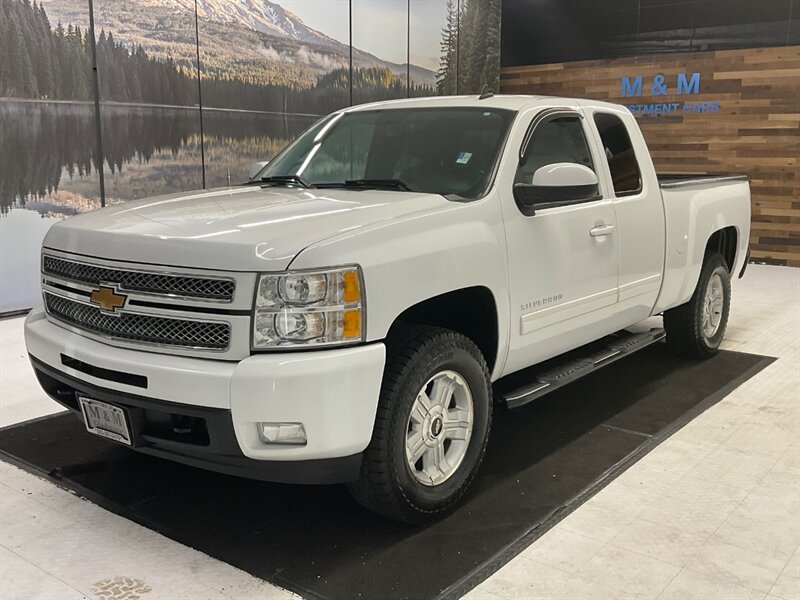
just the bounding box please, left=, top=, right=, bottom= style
left=0, top=344, right=773, bottom=599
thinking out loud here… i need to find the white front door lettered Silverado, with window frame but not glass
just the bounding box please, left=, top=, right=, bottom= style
left=502, top=108, right=619, bottom=373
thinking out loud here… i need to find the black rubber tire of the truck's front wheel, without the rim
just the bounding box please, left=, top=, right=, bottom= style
left=348, top=326, right=492, bottom=523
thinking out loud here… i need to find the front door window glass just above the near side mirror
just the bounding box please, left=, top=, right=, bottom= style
left=514, top=115, right=594, bottom=183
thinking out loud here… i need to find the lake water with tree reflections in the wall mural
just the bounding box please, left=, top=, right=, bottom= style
left=0, top=100, right=317, bottom=312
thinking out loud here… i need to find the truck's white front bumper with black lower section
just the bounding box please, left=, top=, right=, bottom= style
left=25, top=308, right=385, bottom=483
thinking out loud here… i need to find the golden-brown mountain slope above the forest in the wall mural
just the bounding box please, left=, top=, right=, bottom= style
left=40, top=0, right=436, bottom=86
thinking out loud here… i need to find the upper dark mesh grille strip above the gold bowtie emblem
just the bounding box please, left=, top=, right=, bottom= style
left=42, top=255, right=236, bottom=302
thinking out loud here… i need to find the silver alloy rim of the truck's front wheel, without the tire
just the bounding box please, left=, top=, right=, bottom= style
left=406, top=370, right=474, bottom=486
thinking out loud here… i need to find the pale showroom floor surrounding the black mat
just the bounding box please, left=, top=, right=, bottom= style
left=0, top=265, right=800, bottom=600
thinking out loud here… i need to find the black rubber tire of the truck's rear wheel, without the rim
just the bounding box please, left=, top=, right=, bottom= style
left=664, top=252, right=731, bottom=358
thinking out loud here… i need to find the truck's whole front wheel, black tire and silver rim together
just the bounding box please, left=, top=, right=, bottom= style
left=349, top=326, right=492, bottom=523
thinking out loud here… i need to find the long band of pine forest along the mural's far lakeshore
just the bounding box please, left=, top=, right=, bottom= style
left=0, top=0, right=456, bottom=114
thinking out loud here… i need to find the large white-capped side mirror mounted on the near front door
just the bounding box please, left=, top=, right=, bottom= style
left=514, top=163, right=599, bottom=217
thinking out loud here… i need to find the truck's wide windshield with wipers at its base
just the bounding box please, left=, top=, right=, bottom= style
left=256, top=107, right=514, bottom=199
